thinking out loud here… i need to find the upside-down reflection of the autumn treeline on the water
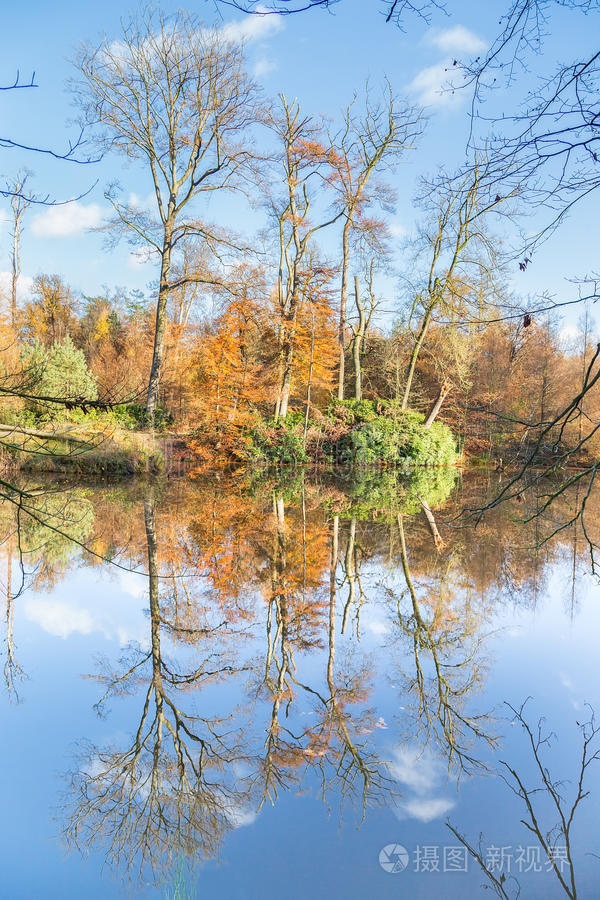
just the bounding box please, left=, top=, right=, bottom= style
left=0, top=471, right=596, bottom=896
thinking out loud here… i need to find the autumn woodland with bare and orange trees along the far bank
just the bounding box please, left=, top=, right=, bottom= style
left=0, top=3, right=598, bottom=488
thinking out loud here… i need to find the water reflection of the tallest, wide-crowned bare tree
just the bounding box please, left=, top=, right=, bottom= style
left=66, top=489, right=255, bottom=874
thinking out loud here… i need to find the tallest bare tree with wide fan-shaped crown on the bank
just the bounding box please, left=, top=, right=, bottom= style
left=75, top=7, right=257, bottom=419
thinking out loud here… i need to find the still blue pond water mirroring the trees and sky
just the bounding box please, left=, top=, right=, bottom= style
left=0, top=473, right=600, bottom=900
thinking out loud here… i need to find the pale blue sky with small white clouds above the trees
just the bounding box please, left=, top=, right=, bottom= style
left=0, top=0, right=597, bottom=333
